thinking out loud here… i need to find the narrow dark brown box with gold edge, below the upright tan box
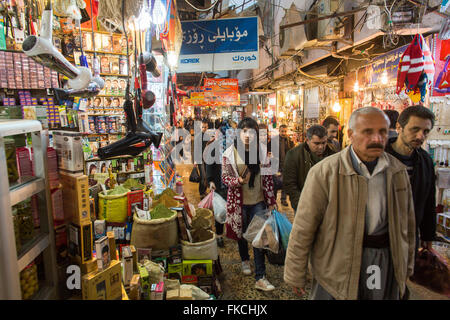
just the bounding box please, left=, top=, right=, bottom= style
left=68, top=222, right=93, bottom=263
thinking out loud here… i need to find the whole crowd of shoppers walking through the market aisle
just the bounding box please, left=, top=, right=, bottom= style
left=188, top=106, right=436, bottom=300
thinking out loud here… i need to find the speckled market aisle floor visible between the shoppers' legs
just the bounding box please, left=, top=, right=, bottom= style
left=177, top=165, right=450, bottom=300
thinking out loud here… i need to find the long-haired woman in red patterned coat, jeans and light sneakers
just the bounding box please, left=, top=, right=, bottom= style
left=222, top=118, right=276, bottom=291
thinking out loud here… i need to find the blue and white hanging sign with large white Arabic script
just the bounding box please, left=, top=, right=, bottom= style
left=177, top=17, right=259, bottom=72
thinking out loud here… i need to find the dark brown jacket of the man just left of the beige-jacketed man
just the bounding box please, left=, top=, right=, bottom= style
left=283, top=142, right=335, bottom=211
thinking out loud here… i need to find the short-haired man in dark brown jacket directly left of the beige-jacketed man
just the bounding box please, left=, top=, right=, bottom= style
left=283, top=125, right=335, bottom=213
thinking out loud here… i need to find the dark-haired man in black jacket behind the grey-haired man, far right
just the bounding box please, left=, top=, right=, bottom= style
left=386, top=105, right=436, bottom=252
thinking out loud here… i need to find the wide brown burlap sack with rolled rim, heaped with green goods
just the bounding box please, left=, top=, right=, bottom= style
left=131, top=214, right=178, bottom=250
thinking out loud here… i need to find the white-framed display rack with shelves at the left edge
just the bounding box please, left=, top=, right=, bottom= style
left=0, top=120, right=57, bottom=300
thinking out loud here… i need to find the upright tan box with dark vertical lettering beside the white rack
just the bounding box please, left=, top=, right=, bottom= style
left=60, top=171, right=91, bottom=224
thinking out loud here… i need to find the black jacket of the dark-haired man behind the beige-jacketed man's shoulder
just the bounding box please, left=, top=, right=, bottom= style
left=386, top=138, right=436, bottom=241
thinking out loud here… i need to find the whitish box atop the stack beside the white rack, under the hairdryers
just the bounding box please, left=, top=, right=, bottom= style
left=53, top=131, right=84, bottom=173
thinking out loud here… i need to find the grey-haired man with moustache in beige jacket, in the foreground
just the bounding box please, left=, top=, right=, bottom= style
left=284, top=107, right=415, bottom=300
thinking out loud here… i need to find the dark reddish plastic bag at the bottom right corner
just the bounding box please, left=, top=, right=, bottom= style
left=411, top=249, right=450, bottom=297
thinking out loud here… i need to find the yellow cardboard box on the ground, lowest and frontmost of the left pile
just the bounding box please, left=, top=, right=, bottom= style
left=81, top=260, right=122, bottom=300
